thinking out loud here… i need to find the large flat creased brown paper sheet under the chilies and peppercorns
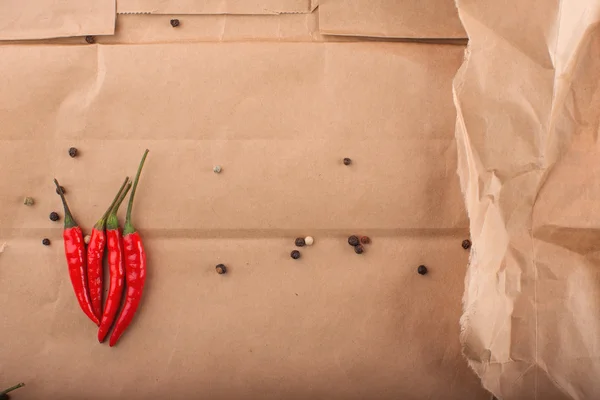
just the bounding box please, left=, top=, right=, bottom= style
left=0, top=3, right=490, bottom=400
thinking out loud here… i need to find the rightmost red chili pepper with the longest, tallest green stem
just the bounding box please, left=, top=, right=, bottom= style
left=109, top=150, right=148, bottom=347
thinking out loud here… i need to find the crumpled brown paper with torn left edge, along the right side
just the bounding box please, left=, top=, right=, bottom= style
left=454, top=0, right=600, bottom=399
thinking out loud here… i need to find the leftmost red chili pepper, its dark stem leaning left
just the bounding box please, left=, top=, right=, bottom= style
left=54, top=179, right=98, bottom=325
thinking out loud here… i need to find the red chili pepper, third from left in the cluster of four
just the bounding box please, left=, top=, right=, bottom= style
left=98, top=182, right=131, bottom=343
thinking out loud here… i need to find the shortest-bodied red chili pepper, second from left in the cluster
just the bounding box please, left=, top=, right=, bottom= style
left=87, top=177, right=129, bottom=320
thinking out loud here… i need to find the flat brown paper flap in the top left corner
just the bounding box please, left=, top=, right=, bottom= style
left=0, top=0, right=115, bottom=40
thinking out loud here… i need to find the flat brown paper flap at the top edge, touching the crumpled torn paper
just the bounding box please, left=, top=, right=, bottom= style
left=319, top=0, right=467, bottom=39
